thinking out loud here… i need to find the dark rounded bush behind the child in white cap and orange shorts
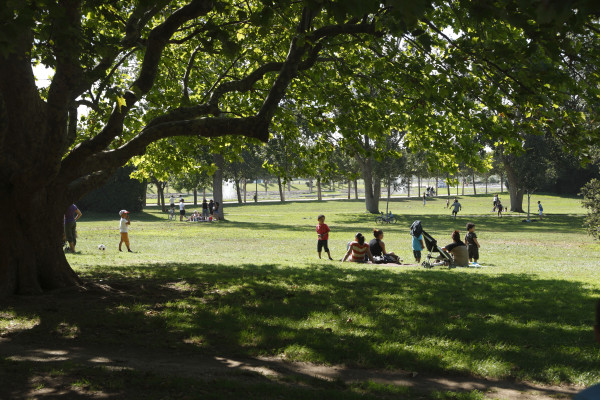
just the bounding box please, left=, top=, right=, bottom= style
left=77, top=166, right=146, bottom=212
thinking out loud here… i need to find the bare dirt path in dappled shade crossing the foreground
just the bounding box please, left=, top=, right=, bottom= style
left=0, top=338, right=580, bottom=400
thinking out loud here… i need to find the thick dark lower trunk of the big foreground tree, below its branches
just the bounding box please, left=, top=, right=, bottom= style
left=0, top=194, right=85, bottom=297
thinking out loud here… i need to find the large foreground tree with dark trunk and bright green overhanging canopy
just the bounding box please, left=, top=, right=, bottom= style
left=0, top=0, right=600, bottom=294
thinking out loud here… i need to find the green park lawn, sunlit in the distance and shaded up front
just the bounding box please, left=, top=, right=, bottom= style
left=0, top=195, right=600, bottom=399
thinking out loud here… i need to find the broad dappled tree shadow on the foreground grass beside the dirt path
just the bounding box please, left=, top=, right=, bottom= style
left=4, top=263, right=600, bottom=396
